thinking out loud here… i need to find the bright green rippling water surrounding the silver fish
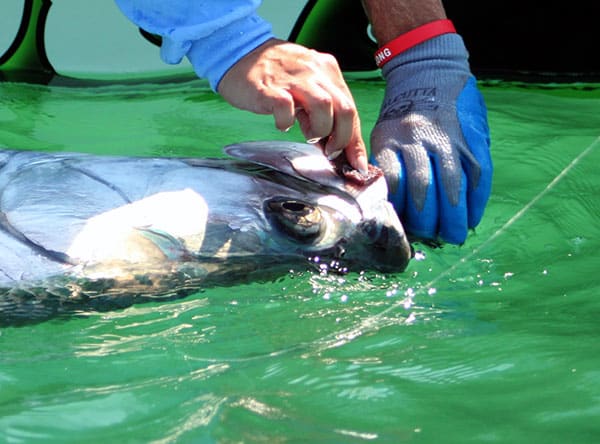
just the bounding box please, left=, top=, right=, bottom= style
left=0, top=81, right=600, bottom=443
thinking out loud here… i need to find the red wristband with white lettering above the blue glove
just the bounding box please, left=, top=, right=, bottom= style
left=375, top=19, right=456, bottom=68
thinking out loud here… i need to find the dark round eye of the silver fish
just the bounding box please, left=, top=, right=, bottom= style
left=265, top=197, right=324, bottom=242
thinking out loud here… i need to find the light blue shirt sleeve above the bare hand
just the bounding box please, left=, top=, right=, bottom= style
left=115, top=0, right=274, bottom=91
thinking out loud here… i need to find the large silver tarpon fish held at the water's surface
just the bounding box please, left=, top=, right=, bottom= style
left=0, top=142, right=411, bottom=324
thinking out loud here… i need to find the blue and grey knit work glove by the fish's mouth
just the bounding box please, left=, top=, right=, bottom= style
left=371, top=34, right=492, bottom=244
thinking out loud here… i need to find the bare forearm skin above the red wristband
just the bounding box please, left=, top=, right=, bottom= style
left=362, top=0, right=446, bottom=45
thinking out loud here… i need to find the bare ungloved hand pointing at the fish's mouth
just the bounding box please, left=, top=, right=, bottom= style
left=218, top=39, right=367, bottom=173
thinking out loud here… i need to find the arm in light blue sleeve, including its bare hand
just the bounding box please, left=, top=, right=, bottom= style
left=115, top=0, right=367, bottom=170
